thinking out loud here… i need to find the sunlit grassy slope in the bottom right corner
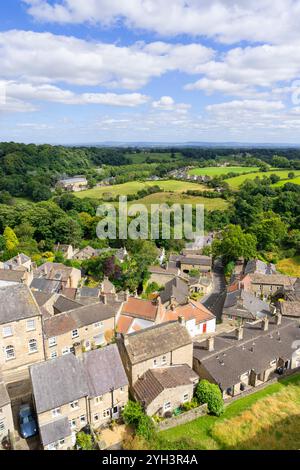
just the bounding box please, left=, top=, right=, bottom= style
left=151, top=374, right=300, bottom=450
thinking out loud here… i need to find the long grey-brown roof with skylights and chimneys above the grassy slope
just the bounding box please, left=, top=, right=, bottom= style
left=193, top=319, right=300, bottom=390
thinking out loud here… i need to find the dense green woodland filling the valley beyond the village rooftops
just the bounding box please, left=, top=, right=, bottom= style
left=0, top=143, right=300, bottom=291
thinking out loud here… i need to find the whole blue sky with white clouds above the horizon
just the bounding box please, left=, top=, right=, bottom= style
left=0, top=0, right=300, bottom=144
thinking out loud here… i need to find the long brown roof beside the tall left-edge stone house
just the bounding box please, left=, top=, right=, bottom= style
left=44, top=302, right=119, bottom=338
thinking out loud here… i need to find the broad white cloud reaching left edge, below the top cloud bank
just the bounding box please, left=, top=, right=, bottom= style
left=0, top=30, right=214, bottom=90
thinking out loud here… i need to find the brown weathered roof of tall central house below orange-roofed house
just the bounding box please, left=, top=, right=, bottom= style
left=120, top=322, right=192, bottom=364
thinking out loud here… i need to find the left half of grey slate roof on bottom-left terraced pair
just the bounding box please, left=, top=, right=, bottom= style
left=30, top=354, right=89, bottom=413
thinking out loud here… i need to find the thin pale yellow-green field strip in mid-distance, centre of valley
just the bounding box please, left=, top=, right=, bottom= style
left=75, top=180, right=207, bottom=199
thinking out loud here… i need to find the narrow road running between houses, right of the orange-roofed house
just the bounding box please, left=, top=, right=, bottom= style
left=201, top=260, right=226, bottom=320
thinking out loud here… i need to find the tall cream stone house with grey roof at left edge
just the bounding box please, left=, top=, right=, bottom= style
left=0, top=284, right=45, bottom=383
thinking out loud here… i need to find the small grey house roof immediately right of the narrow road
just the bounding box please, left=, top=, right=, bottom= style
left=223, top=289, right=271, bottom=320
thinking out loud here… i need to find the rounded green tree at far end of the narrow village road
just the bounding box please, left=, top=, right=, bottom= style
left=212, top=225, right=257, bottom=263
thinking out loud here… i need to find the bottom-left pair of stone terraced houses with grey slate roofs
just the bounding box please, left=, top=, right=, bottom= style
left=30, top=345, right=128, bottom=450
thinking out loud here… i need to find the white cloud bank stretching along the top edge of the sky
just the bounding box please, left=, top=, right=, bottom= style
left=23, top=0, right=300, bottom=43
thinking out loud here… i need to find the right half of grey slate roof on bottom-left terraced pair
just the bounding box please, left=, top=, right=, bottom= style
left=81, top=344, right=128, bottom=397
